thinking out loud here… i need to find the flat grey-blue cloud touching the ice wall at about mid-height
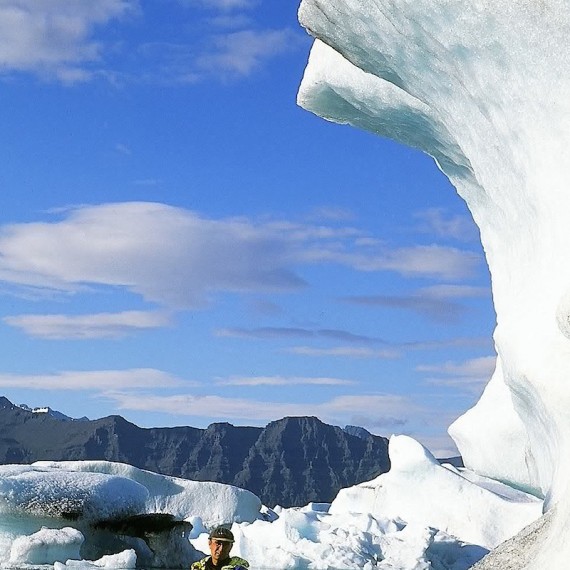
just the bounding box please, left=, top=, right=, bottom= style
left=344, top=285, right=490, bottom=323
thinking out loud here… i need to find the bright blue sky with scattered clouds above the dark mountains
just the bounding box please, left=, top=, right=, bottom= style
left=0, top=0, right=495, bottom=452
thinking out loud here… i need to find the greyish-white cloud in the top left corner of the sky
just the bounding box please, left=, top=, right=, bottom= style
left=0, top=0, right=138, bottom=82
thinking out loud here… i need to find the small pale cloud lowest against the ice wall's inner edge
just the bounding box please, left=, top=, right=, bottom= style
left=416, top=356, right=497, bottom=392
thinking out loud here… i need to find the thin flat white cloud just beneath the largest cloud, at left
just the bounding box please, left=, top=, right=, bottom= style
left=3, top=311, right=171, bottom=340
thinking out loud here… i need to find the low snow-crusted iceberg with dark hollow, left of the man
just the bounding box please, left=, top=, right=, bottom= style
left=0, top=461, right=261, bottom=568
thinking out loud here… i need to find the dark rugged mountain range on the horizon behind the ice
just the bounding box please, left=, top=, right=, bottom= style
left=0, top=397, right=390, bottom=507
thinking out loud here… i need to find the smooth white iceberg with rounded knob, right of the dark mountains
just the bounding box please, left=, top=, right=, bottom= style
left=330, top=435, right=542, bottom=549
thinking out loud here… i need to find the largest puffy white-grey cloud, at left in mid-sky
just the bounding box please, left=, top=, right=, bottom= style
left=0, top=203, right=303, bottom=308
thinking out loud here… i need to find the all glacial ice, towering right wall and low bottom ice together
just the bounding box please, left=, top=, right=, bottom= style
left=0, top=0, right=570, bottom=570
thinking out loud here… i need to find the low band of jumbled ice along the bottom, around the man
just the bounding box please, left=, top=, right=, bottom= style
left=0, top=446, right=541, bottom=570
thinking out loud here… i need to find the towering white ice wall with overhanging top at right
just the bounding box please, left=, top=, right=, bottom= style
left=298, top=0, right=570, bottom=570
